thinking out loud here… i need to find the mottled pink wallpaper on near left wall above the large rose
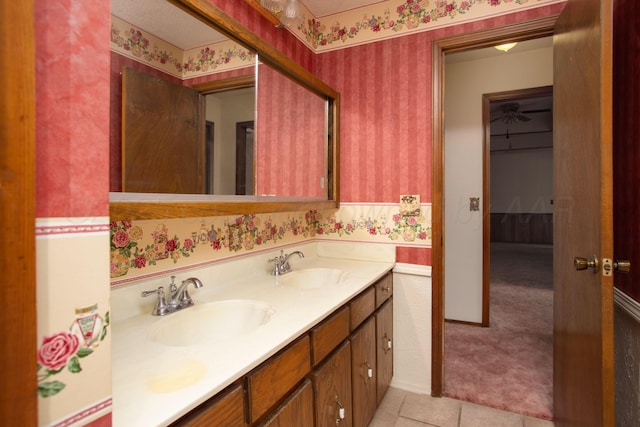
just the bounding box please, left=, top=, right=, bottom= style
left=34, top=0, right=110, bottom=217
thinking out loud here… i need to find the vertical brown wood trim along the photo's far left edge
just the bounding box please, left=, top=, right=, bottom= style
left=0, top=0, right=38, bottom=426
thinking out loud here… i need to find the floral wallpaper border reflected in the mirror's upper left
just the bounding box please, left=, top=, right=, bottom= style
left=111, top=15, right=256, bottom=79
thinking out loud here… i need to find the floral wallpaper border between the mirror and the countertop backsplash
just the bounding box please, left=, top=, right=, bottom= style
left=110, top=203, right=431, bottom=284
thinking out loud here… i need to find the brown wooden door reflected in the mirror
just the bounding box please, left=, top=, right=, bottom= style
left=122, top=68, right=206, bottom=194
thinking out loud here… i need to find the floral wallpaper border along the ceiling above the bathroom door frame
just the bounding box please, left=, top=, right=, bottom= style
left=291, top=0, right=565, bottom=52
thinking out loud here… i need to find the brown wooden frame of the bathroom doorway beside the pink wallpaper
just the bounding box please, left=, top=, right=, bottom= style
left=431, top=14, right=559, bottom=397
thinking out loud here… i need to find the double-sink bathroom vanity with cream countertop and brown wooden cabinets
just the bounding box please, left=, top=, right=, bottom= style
left=112, top=242, right=395, bottom=427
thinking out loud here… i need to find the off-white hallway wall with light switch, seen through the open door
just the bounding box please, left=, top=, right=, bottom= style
left=444, top=47, right=553, bottom=323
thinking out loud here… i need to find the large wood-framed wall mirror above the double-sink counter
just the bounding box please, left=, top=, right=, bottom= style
left=110, top=0, right=339, bottom=219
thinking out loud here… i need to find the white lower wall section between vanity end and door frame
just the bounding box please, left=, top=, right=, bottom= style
left=391, top=263, right=431, bottom=394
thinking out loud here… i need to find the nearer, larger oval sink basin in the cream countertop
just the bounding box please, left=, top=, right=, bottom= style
left=149, top=300, right=273, bottom=347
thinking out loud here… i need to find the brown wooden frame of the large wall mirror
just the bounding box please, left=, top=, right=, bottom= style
left=109, top=0, right=340, bottom=220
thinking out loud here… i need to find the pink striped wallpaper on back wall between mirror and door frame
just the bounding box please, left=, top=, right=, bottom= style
left=315, top=4, right=563, bottom=207
